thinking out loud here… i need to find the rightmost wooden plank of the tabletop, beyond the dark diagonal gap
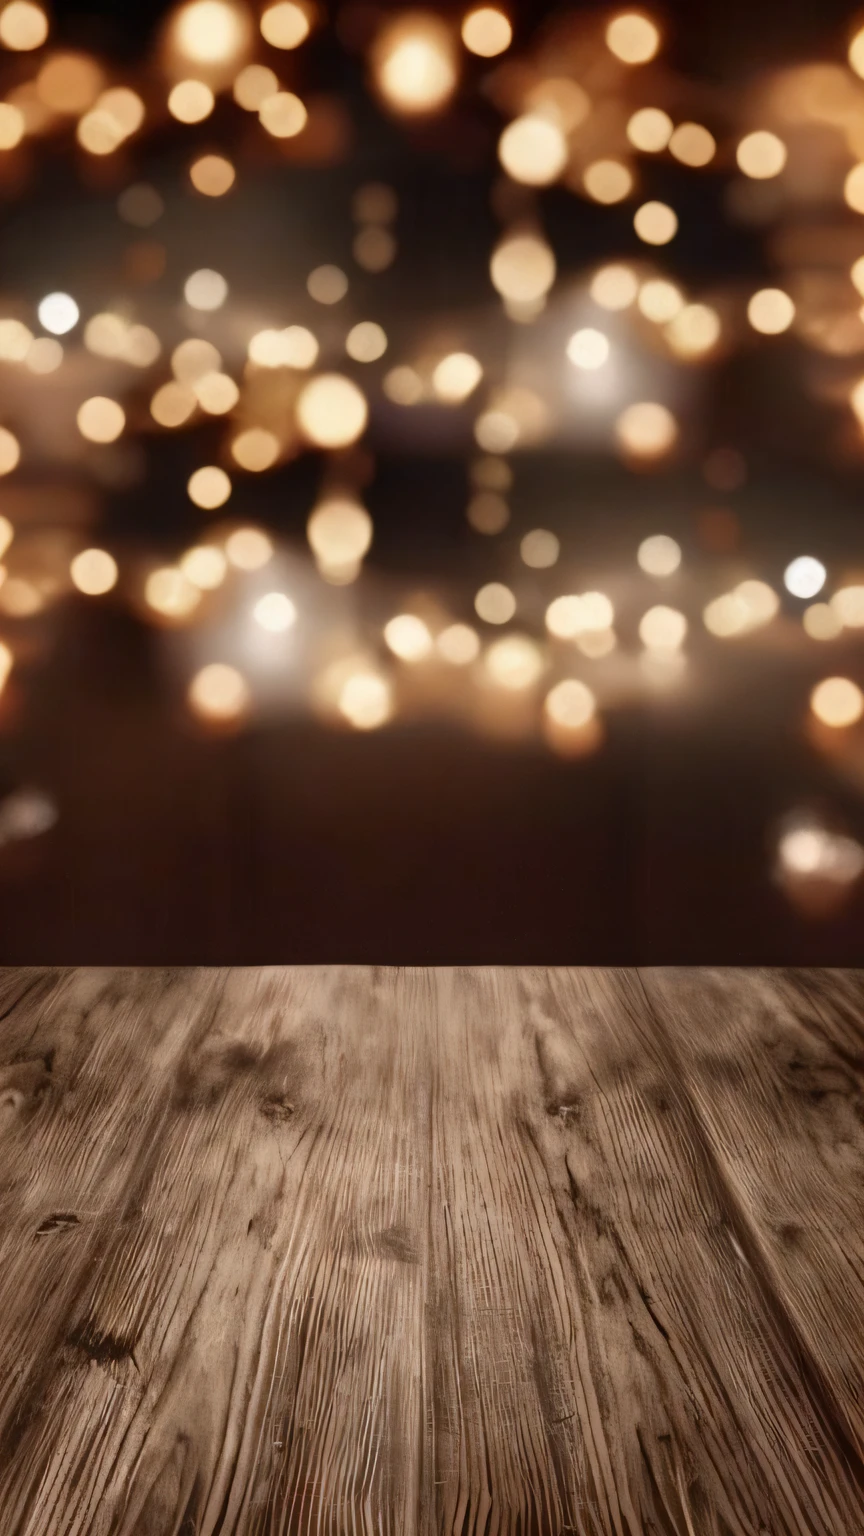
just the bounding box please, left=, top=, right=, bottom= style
left=643, top=969, right=864, bottom=1459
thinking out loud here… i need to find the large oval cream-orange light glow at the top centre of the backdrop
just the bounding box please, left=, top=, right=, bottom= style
left=372, top=11, right=457, bottom=115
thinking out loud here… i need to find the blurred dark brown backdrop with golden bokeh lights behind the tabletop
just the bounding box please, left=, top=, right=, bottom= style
left=0, top=0, right=864, bottom=965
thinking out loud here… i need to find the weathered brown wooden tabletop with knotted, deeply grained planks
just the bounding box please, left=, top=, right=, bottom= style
left=0, top=968, right=864, bottom=1536
